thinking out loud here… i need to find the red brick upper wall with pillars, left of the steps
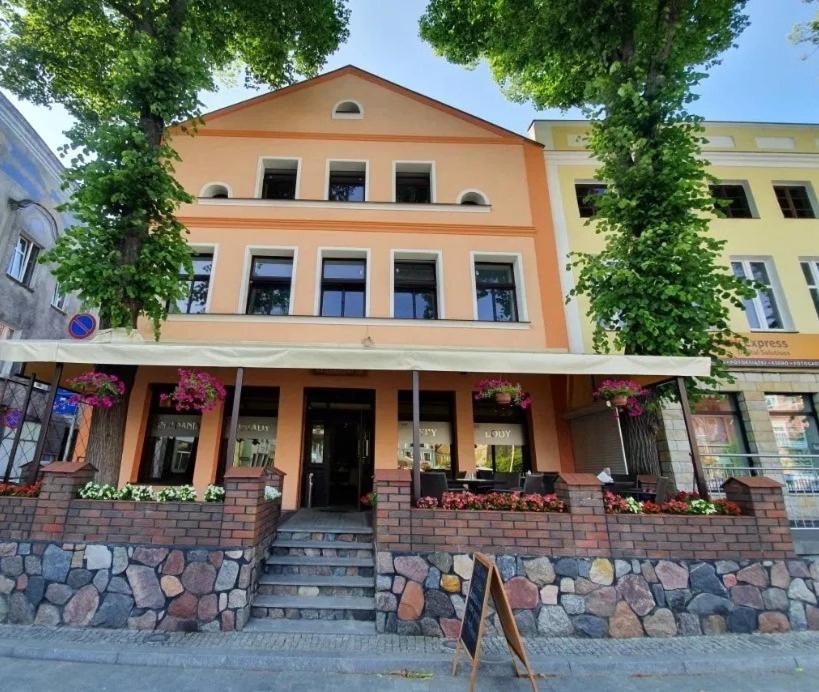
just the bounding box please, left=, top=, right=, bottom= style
left=0, top=463, right=281, bottom=547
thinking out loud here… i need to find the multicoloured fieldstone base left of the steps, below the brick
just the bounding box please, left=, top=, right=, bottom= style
left=0, top=542, right=259, bottom=631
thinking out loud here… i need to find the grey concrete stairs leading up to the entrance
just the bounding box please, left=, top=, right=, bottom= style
left=245, top=524, right=375, bottom=634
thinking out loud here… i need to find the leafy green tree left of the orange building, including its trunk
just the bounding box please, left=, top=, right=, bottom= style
left=0, top=0, right=349, bottom=482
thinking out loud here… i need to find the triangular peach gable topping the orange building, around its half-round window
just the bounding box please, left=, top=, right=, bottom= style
left=200, top=68, right=524, bottom=140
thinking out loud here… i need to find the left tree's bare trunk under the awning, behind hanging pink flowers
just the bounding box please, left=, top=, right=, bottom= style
left=85, top=365, right=137, bottom=485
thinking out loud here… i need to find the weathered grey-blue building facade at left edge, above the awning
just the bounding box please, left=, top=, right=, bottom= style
left=0, top=94, right=79, bottom=348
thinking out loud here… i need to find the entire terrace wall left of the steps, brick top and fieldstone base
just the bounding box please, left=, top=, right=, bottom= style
left=0, top=463, right=282, bottom=631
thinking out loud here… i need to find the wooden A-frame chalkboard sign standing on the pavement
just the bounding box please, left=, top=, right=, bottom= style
left=452, top=553, right=537, bottom=692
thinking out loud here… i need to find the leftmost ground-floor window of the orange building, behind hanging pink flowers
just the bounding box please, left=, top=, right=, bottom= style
left=139, top=387, right=202, bottom=485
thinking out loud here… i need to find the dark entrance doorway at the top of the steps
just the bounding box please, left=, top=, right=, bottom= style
left=302, top=389, right=375, bottom=508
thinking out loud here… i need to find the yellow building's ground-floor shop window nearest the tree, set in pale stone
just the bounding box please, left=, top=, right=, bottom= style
left=693, top=394, right=749, bottom=467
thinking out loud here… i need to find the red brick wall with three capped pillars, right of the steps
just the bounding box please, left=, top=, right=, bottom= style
left=376, top=470, right=794, bottom=560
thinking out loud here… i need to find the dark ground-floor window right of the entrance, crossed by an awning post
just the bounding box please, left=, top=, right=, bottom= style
left=398, top=391, right=456, bottom=474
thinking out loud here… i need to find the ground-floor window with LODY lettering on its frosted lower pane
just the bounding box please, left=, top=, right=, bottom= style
left=474, top=401, right=531, bottom=473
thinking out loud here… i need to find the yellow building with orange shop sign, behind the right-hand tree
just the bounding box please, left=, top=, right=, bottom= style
left=529, top=120, right=819, bottom=498
